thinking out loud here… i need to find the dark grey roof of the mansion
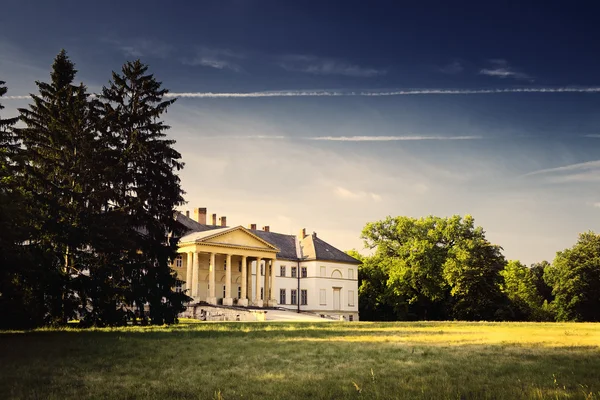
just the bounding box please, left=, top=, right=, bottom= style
left=175, top=212, right=360, bottom=264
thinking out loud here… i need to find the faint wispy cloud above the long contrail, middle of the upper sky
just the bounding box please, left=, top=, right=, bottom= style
left=279, top=55, right=387, bottom=78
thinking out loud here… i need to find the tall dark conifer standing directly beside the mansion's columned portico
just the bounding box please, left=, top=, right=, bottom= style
left=100, top=60, right=188, bottom=324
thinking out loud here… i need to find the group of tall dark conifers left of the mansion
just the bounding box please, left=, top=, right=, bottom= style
left=0, top=50, right=188, bottom=329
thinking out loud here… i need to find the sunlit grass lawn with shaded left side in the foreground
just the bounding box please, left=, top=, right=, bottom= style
left=0, top=321, right=600, bottom=400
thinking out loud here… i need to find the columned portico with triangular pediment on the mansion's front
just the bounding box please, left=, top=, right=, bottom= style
left=178, top=226, right=279, bottom=307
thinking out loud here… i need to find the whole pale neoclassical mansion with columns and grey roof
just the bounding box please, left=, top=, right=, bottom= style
left=172, top=208, right=360, bottom=321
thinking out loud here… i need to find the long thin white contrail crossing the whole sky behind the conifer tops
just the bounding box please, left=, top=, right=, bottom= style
left=7, top=86, right=600, bottom=100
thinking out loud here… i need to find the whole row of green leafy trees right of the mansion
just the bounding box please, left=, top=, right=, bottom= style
left=351, top=215, right=600, bottom=321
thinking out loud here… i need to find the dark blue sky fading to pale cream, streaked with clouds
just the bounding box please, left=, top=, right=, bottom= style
left=0, top=0, right=600, bottom=264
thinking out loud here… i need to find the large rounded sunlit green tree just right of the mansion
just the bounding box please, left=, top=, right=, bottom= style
left=362, top=215, right=506, bottom=319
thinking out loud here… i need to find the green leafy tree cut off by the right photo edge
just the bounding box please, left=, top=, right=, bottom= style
left=544, top=231, right=600, bottom=322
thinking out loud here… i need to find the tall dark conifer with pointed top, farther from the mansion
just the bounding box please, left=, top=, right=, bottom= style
left=15, top=50, right=100, bottom=324
